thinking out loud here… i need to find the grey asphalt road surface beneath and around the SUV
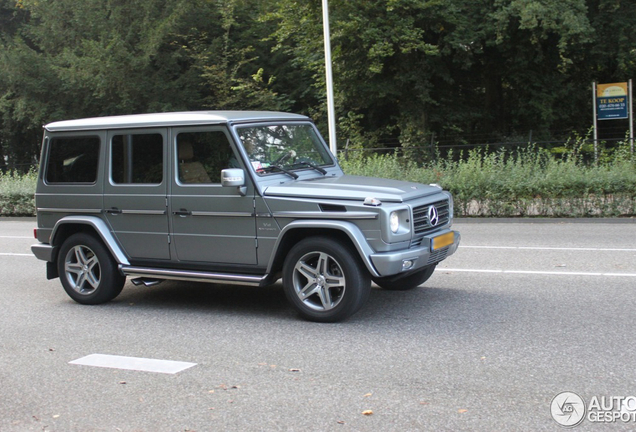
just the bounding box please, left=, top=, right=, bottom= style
left=0, top=220, right=636, bottom=432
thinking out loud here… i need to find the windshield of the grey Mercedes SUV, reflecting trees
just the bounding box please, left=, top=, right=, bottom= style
left=237, top=124, right=334, bottom=175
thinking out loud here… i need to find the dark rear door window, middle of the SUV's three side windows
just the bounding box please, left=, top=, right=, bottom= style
left=111, top=134, right=163, bottom=184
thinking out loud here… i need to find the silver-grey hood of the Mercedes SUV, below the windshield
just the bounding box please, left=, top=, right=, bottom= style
left=264, top=175, right=441, bottom=202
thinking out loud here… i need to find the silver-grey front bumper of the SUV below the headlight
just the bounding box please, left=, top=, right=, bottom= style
left=369, top=230, right=461, bottom=276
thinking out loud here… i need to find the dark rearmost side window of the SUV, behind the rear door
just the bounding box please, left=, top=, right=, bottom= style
left=46, top=136, right=100, bottom=184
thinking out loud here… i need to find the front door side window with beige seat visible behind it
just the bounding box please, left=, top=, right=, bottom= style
left=177, top=131, right=239, bottom=185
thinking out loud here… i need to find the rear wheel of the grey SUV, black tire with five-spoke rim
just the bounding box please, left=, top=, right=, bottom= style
left=57, top=233, right=126, bottom=305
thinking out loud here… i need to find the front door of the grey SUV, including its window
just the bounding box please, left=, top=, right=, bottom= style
left=170, top=126, right=256, bottom=265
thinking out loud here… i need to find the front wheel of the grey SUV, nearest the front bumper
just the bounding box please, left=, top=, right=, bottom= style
left=283, top=237, right=371, bottom=322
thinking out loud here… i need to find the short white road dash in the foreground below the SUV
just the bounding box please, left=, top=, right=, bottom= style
left=69, top=354, right=197, bottom=374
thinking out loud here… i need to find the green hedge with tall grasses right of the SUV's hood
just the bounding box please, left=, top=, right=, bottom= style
left=340, top=148, right=636, bottom=217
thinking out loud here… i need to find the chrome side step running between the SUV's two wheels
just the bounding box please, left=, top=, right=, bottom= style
left=120, top=266, right=268, bottom=286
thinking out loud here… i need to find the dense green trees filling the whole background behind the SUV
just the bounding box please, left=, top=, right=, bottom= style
left=0, top=0, right=636, bottom=167
